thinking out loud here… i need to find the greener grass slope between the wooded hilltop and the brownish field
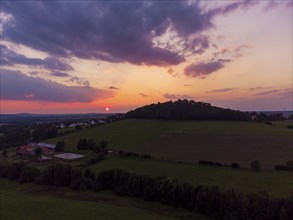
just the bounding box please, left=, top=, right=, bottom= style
left=46, top=119, right=293, bottom=150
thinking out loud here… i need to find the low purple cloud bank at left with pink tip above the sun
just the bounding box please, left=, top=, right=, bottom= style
left=0, top=70, right=114, bottom=102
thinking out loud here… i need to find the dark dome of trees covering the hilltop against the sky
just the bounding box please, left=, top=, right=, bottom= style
left=126, top=99, right=249, bottom=121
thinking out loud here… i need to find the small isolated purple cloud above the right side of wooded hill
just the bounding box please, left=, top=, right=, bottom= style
left=184, top=60, right=225, bottom=78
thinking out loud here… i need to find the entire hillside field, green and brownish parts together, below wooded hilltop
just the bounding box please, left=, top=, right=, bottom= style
left=48, top=119, right=293, bottom=169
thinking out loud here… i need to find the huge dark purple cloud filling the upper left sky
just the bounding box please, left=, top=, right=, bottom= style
left=1, top=1, right=215, bottom=66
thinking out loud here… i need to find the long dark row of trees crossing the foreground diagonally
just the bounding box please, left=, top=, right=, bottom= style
left=0, top=163, right=293, bottom=220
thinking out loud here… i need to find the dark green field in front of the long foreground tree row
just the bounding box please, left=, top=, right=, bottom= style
left=0, top=179, right=208, bottom=220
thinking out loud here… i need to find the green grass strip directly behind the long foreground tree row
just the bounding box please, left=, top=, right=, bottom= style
left=90, top=157, right=293, bottom=197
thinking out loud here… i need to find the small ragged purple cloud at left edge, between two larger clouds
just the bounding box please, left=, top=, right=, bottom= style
left=0, top=44, right=73, bottom=71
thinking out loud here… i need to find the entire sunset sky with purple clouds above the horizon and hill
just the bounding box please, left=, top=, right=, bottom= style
left=0, top=0, right=293, bottom=113
